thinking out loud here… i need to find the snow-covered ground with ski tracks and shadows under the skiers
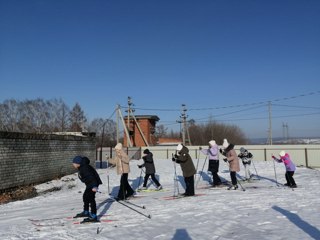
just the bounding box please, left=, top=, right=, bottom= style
left=0, top=159, right=320, bottom=240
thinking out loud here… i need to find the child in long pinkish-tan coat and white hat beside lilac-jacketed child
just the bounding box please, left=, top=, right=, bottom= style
left=220, top=139, right=240, bottom=190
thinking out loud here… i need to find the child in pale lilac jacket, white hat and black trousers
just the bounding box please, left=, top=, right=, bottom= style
left=199, top=140, right=221, bottom=187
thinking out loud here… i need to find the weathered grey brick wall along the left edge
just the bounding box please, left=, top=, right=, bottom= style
left=0, top=132, right=95, bottom=191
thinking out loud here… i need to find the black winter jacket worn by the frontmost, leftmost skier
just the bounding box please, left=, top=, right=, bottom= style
left=78, top=157, right=102, bottom=189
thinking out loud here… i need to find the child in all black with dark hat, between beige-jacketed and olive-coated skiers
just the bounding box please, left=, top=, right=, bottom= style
left=138, top=149, right=162, bottom=190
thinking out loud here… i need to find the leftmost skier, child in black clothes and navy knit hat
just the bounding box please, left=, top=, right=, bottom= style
left=72, top=156, right=102, bottom=222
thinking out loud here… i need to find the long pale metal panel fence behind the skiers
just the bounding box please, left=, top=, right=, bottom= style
left=97, top=145, right=320, bottom=168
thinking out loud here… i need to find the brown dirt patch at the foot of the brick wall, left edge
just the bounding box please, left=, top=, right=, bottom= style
left=0, top=186, right=38, bottom=204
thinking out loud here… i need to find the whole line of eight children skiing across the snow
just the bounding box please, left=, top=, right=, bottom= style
left=72, top=139, right=297, bottom=222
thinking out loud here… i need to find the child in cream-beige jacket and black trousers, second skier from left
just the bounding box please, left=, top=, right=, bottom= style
left=109, top=143, right=134, bottom=201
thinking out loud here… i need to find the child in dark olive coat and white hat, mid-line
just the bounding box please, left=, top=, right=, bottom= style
left=172, top=144, right=196, bottom=197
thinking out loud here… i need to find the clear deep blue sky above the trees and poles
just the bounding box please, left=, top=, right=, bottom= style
left=0, top=0, right=320, bottom=138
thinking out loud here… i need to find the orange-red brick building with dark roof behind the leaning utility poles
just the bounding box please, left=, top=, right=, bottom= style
left=123, top=115, right=160, bottom=147
